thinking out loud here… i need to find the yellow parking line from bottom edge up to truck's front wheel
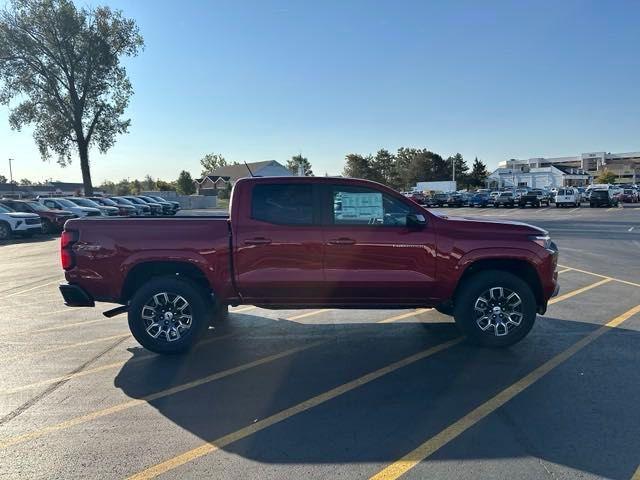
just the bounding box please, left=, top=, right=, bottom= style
left=129, top=338, right=462, bottom=480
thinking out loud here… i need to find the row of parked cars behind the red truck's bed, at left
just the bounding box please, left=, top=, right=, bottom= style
left=0, top=195, right=180, bottom=240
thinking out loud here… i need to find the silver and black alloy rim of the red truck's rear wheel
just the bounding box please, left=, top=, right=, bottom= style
left=141, top=292, right=192, bottom=342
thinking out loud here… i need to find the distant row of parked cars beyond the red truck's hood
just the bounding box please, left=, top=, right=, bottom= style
left=405, top=185, right=640, bottom=208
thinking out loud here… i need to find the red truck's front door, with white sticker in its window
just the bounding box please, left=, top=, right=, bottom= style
left=322, top=181, right=436, bottom=304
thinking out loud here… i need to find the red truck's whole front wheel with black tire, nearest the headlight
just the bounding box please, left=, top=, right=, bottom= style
left=454, top=270, right=537, bottom=347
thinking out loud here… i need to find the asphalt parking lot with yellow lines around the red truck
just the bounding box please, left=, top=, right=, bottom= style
left=0, top=206, right=640, bottom=480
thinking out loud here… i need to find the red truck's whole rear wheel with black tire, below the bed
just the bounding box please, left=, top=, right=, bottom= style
left=129, top=276, right=209, bottom=354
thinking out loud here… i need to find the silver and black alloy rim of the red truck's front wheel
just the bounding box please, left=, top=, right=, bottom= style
left=474, top=287, right=524, bottom=337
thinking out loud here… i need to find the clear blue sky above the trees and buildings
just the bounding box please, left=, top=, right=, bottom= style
left=0, top=0, right=640, bottom=183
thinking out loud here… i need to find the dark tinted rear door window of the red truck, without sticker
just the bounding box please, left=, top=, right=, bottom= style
left=251, top=184, right=313, bottom=225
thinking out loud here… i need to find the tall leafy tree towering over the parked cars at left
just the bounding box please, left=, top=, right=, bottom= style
left=0, top=0, right=144, bottom=195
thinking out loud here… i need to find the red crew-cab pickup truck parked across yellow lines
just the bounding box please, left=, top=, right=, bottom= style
left=60, top=177, right=558, bottom=353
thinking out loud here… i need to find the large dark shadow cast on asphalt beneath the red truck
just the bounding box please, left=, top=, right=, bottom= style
left=115, top=314, right=640, bottom=480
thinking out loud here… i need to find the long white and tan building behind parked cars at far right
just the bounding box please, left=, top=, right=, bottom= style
left=491, top=152, right=640, bottom=186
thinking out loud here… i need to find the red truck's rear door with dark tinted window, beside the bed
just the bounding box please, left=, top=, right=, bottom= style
left=231, top=178, right=323, bottom=303
